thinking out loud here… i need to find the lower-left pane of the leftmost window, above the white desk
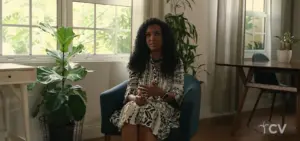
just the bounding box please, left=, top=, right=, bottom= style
left=2, top=27, right=29, bottom=55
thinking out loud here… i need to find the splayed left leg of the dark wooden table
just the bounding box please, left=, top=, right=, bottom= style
left=231, top=67, right=253, bottom=135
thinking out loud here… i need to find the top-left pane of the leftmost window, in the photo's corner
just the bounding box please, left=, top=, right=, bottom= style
left=2, top=0, right=29, bottom=25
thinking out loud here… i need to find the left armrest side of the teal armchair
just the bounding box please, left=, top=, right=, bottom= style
left=100, top=80, right=128, bottom=134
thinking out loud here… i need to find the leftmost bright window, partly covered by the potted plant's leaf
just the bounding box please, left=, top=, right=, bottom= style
left=0, top=0, right=57, bottom=56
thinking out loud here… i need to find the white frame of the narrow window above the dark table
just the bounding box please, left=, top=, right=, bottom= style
left=243, top=0, right=271, bottom=59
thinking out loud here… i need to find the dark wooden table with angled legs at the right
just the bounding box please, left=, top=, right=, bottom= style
left=216, top=61, right=300, bottom=134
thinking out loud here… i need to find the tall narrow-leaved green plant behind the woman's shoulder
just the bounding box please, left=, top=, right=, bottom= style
left=165, top=0, right=204, bottom=76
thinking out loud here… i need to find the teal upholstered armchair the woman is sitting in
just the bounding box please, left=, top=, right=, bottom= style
left=100, top=74, right=201, bottom=141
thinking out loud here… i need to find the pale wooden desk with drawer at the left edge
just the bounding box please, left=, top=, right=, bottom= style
left=0, top=63, right=36, bottom=141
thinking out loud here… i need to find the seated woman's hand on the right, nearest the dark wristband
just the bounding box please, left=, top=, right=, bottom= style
left=138, top=82, right=165, bottom=96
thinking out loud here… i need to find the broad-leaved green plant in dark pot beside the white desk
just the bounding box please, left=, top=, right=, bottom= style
left=29, top=23, right=89, bottom=141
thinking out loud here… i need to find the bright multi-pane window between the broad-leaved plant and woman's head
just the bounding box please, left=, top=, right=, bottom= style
left=72, top=2, right=131, bottom=54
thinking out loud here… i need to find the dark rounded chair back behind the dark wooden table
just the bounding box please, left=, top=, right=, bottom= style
left=252, top=53, right=278, bottom=85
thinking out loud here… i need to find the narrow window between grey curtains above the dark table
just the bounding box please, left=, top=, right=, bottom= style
left=244, top=0, right=270, bottom=57
